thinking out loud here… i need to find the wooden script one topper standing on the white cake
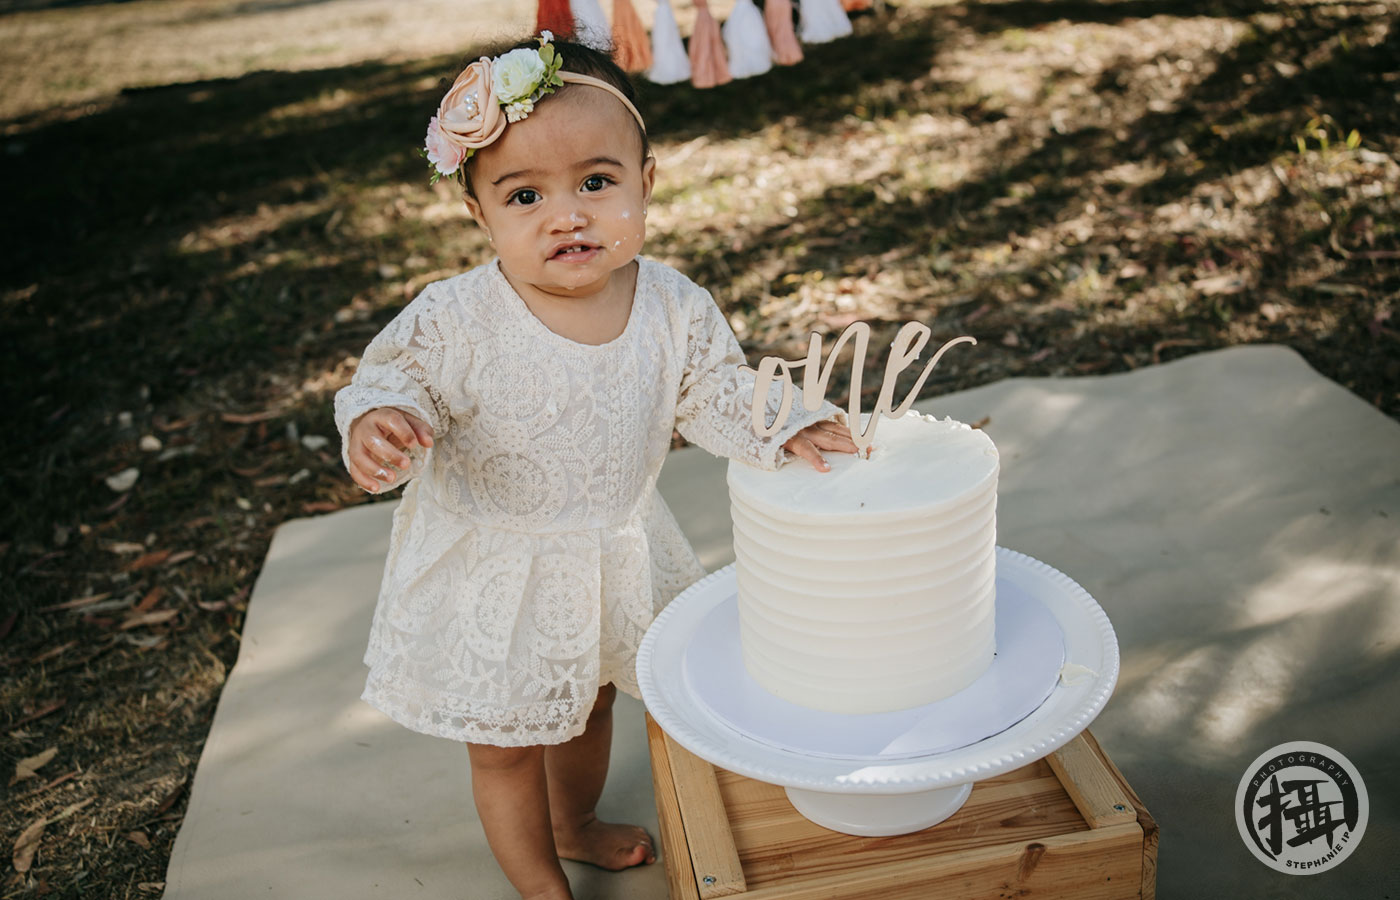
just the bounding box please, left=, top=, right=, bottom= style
left=743, top=322, right=977, bottom=456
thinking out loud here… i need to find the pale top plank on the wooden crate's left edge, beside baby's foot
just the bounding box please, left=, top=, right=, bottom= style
left=662, top=733, right=748, bottom=900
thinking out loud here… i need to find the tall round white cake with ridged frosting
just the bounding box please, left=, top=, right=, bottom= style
left=728, top=412, right=998, bottom=712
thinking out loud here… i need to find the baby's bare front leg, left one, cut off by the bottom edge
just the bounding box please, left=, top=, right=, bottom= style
left=466, top=743, right=573, bottom=900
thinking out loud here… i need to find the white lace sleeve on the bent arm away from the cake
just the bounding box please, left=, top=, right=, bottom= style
left=335, top=286, right=451, bottom=490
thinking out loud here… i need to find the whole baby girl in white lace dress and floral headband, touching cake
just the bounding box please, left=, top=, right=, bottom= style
left=336, top=32, right=855, bottom=897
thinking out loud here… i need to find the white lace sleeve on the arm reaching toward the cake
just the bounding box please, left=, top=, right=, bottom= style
left=676, top=288, right=846, bottom=470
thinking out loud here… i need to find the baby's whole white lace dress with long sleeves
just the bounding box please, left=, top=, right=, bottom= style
left=335, top=258, right=846, bottom=746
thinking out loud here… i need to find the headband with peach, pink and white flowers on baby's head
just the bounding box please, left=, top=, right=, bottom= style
left=423, top=31, right=647, bottom=183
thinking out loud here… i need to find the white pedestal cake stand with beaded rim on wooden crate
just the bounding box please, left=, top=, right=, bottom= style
left=637, top=547, right=1119, bottom=836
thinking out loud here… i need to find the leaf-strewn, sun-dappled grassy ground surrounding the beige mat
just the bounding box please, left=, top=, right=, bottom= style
left=0, top=0, right=1400, bottom=899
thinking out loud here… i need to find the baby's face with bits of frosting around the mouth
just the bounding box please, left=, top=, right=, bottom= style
left=466, top=85, right=655, bottom=298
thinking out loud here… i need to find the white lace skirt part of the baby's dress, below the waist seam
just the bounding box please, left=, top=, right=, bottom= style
left=361, top=483, right=704, bottom=746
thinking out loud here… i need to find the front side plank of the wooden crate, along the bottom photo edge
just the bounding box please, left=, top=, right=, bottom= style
left=743, top=822, right=1142, bottom=900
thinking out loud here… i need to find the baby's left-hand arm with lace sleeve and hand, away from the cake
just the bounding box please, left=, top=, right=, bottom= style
left=335, top=286, right=455, bottom=493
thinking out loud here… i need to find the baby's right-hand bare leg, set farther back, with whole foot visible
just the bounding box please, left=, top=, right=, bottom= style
left=545, top=684, right=657, bottom=871
